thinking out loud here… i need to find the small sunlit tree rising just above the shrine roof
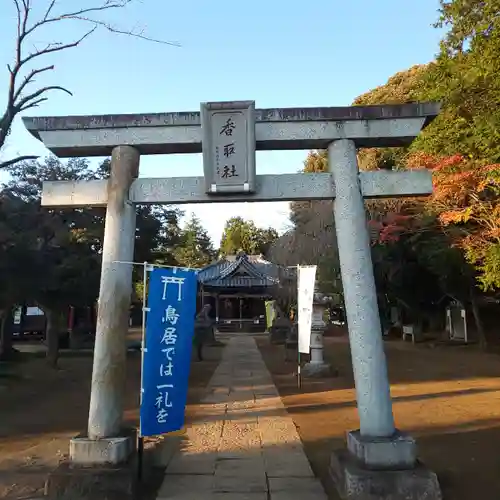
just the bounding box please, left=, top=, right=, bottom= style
left=220, top=217, right=278, bottom=255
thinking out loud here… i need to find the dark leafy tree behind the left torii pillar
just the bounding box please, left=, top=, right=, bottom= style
left=0, top=157, right=184, bottom=366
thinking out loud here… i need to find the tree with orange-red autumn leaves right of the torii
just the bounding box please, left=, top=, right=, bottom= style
left=371, top=153, right=500, bottom=347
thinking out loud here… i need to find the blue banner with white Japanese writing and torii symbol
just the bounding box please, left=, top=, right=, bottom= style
left=140, top=268, right=198, bottom=436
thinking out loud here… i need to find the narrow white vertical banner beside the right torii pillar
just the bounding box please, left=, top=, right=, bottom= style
left=297, top=266, right=316, bottom=354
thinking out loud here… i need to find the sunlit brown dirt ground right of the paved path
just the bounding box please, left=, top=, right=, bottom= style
left=258, top=335, right=500, bottom=500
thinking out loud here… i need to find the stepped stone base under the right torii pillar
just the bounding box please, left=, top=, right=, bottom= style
left=330, top=431, right=442, bottom=500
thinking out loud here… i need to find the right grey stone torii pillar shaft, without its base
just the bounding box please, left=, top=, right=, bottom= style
left=328, top=140, right=394, bottom=438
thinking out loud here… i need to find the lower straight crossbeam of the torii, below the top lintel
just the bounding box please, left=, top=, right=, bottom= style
left=42, top=170, right=432, bottom=207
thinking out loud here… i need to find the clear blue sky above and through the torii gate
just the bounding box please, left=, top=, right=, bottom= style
left=0, top=0, right=441, bottom=244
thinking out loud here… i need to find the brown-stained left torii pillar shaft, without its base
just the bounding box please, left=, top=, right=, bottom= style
left=88, top=146, right=139, bottom=440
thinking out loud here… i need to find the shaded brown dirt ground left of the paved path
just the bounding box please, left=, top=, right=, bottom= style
left=0, top=338, right=222, bottom=500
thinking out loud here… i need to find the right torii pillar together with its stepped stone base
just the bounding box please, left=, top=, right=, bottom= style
left=328, top=139, right=441, bottom=500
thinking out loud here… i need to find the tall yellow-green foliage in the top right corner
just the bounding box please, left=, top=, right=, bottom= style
left=413, top=0, right=500, bottom=162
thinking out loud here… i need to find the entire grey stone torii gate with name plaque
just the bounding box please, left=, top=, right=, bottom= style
left=24, top=101, right=440, bottom=500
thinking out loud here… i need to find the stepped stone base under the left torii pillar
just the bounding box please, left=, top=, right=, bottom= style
left=45, top=429, right=137, bottom=500
